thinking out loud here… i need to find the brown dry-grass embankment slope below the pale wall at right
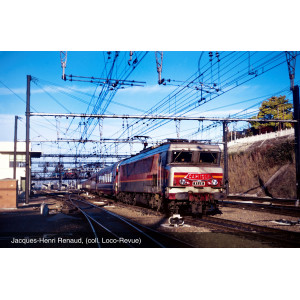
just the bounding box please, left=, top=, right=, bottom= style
left=229, top=139, right=296, bottom=198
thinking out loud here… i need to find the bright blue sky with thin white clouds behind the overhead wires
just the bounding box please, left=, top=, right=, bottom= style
left=0, top=51, right=299, bottom=156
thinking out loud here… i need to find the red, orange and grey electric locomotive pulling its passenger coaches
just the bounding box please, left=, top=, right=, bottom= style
left=82, top=139, right=224, bottom=214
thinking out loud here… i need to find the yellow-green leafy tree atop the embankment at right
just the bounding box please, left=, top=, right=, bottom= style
left=250, top=96, right=293, bottom=129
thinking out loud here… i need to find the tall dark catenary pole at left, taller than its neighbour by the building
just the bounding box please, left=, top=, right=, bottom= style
left=25, top=75, right=31, bottom=204
